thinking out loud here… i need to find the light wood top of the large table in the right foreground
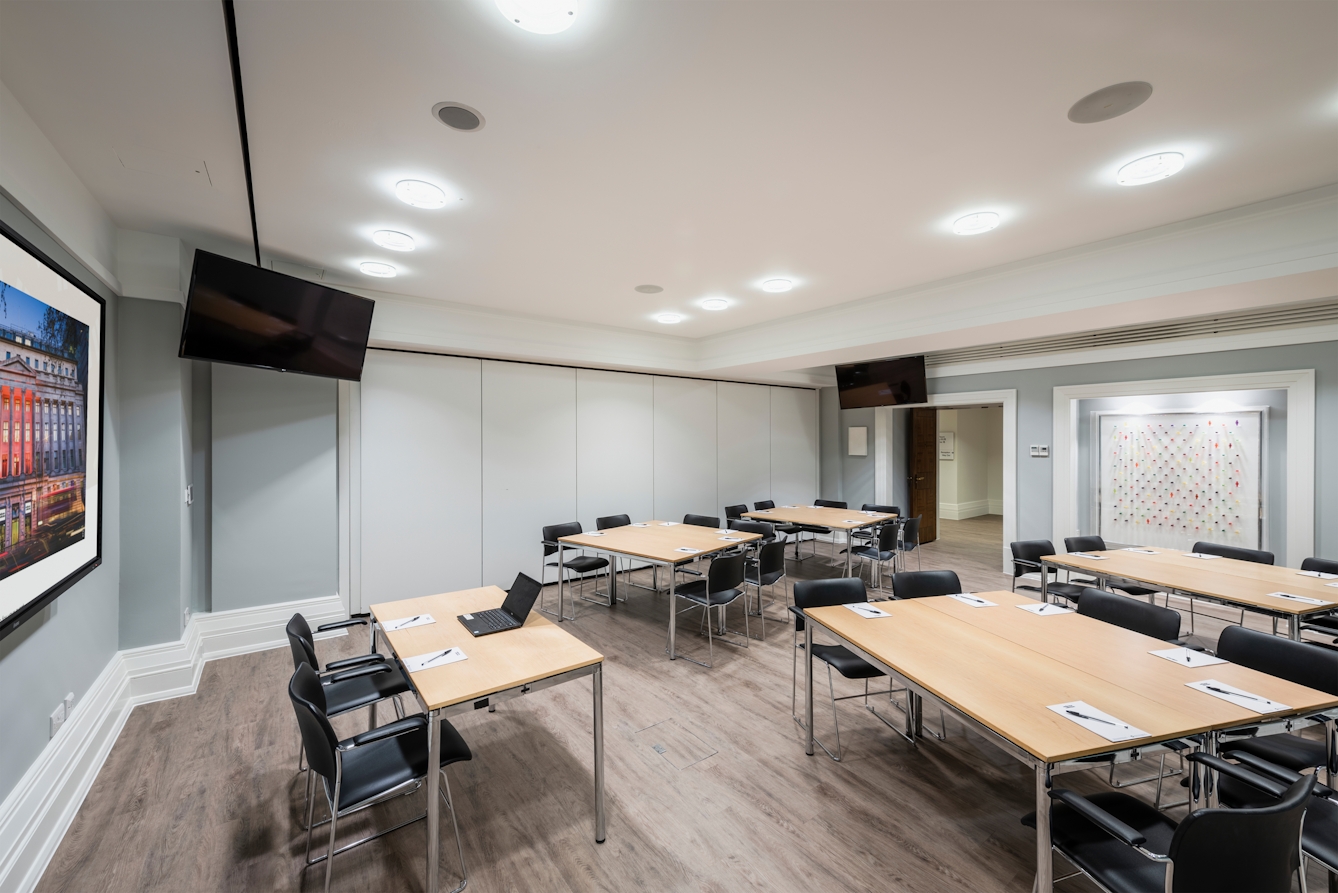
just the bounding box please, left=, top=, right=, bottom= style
left=805, top=593, right=1338, bottom=763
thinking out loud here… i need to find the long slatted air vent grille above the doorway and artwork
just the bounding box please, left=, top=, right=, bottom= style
left=925, top=300, right=1338, bottom=366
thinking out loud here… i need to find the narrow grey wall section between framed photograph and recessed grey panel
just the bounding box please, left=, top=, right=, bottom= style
left=118, top=297, right=190, bottom=648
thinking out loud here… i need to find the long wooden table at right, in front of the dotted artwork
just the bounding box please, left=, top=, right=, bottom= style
left=1041, top=548, right=1338, bottom=641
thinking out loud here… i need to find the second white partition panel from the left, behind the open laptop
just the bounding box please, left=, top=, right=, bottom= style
left=483, top=360, right=577, bottom=589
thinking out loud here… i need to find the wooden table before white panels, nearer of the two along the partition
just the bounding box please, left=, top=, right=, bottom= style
left=558, top=521, right=761, bottom=660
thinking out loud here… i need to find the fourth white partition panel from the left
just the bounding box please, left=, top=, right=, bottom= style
left=654, top=376, right=720, bottom=521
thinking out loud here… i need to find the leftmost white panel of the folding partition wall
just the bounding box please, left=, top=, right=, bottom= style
left=360, top=351, right=483, bottom=605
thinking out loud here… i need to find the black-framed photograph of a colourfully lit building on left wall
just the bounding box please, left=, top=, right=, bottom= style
left=0, top=224, right=106, bottom=639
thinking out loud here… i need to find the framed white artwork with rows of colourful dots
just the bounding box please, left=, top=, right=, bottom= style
left=1093, top=408, right=1267, bottom=549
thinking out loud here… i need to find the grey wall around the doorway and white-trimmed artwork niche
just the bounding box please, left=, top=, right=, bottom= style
left=822, top=341, right=1338, bottom=558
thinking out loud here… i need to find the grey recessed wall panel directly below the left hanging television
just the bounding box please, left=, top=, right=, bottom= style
left=211, top=366, right=339, bottom=611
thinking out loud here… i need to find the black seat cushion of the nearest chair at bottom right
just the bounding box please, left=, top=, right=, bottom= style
left=1022, top=791, right=1175, bottom=893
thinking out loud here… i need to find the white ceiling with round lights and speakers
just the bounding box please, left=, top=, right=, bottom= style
left=0, top=0, right=1338, bottom=350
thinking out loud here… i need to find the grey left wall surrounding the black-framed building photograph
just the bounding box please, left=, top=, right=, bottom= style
left=0, top=195, right=120, bottom=799
